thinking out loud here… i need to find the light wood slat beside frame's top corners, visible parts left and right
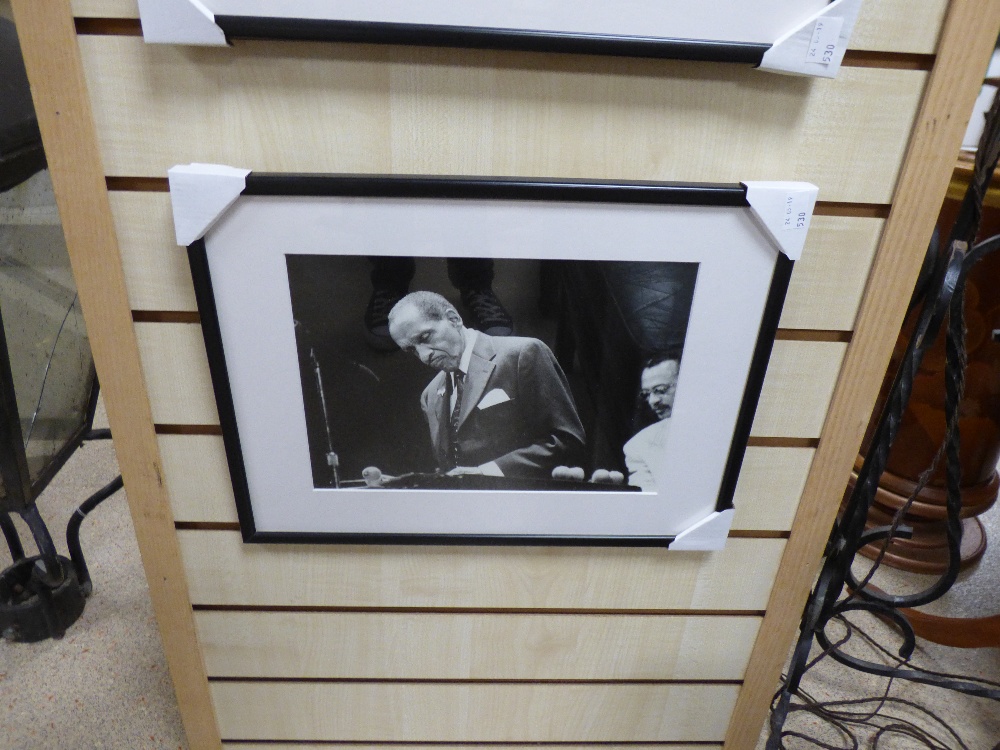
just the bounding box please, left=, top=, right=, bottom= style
left=110, top=192, right=884, bottom=331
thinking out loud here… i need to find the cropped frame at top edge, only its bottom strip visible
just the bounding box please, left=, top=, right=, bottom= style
left=139, top=0, right=861, bottom=78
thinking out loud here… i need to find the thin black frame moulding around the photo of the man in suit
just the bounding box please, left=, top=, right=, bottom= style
left=175, top=173, right=814, bottom=547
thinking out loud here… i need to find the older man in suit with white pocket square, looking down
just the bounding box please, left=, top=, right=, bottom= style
left=389, top=292, right=584, bottom=478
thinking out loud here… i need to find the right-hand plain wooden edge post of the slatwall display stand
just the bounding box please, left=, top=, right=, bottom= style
left=724, top=0, right=1000, bottom=750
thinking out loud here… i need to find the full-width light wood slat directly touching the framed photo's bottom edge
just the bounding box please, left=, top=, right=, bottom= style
left=177, top=531, right=785, bottom=612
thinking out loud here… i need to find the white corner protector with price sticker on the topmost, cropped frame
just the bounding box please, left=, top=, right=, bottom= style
left=760, top=0, right=861, bottom=78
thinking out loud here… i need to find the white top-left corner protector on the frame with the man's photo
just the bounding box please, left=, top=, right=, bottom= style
left=167, top=164, right=250, bottom=247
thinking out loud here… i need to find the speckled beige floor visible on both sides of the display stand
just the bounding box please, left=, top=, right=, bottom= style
left=0, top=402, right=1000, bottom=750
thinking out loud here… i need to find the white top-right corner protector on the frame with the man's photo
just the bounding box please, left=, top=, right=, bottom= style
left=743, top=182, right=819, bottom=260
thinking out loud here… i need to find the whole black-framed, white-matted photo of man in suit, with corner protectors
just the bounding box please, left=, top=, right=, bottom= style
left=170, top=165, right=816, bottom=549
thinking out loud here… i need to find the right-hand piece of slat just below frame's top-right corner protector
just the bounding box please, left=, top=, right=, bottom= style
left=780, top=216, right=885, bottom=331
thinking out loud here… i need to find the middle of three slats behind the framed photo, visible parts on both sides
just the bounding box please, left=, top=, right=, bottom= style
left=135, top=323, right=846, bottom=438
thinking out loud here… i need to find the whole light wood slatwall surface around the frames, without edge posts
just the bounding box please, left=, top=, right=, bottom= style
left=35, top=0, right=964, bottom=750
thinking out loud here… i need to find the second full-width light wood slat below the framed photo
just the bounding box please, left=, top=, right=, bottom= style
left=195, top=611, right=760, bottom=680
